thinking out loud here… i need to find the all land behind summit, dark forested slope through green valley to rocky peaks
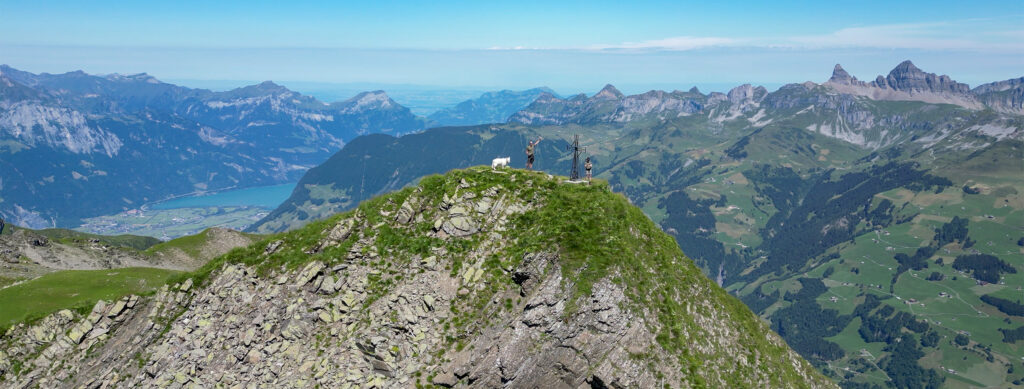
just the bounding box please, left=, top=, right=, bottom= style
left=253, top=61, right=1024, bottom=388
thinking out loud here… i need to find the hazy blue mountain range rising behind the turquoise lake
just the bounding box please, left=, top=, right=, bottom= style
left=0, top=66, right=428, bottom=227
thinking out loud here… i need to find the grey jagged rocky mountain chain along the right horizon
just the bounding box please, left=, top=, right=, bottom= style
left=508, top=60, right=1024, bottom=125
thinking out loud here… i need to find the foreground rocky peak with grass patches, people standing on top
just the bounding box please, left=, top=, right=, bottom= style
left=0, top=168, right=835, bottom=388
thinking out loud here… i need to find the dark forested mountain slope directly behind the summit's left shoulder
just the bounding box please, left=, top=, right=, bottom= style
left=250, top=125, right=568, bottom=232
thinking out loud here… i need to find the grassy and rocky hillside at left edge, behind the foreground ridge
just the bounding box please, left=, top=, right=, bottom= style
left=0, top=224, right=256, bottom=329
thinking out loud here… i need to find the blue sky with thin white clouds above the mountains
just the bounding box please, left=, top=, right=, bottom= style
left=0, top=0, right=1024, bottom=93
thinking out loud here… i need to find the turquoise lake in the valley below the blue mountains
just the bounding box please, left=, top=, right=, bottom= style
left=150, top=182, right=296, bottom=210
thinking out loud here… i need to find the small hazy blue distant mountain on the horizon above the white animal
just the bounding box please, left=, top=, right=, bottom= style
left=429, top=87, right=556, bottom=126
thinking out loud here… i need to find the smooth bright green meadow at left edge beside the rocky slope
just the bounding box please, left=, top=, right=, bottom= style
left=0, top=267, right=178, bottom=329
